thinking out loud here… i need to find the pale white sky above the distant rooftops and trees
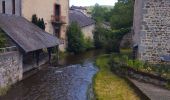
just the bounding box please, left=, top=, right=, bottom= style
left=70, top=0, right=117, bottom=6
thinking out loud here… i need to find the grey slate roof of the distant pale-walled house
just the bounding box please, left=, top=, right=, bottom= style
left=69, top=10, right=95, bottom=28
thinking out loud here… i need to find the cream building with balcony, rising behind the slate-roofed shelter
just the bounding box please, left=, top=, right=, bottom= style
left=0, top=0, right=69, bottom=51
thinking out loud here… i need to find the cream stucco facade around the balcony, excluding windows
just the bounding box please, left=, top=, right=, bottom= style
left=22, top=0, right=69, bottom=51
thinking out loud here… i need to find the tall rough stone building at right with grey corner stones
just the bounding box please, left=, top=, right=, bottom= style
left=133, top=0, right=170, bottom=63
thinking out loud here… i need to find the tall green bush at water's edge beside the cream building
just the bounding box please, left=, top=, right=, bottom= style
left=67, top=22, right=85, bottom=54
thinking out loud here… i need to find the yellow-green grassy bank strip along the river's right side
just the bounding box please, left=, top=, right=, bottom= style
left=94, top=55, right=140, bottom=100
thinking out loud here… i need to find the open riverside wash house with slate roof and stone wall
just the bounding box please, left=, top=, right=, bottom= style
left=0, top=14, right=60, bottom=88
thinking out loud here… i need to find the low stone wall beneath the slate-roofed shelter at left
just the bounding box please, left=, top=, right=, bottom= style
left=0, top=51, right=23, bottom=88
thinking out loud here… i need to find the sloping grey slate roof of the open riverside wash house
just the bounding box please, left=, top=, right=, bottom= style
left=0, top=14, right=60, bottom=53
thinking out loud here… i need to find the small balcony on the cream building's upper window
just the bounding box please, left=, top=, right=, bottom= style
left=51, top=15, right=66, bottom=24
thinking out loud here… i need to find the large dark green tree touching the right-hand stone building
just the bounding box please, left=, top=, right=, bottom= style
left=110, top=0, right=134, bottom=29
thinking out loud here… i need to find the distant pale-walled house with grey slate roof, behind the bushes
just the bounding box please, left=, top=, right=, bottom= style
left=69, top=10, right=95, bottom=40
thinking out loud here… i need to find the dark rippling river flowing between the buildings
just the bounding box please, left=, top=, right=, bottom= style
left=0, top=51, right=102, bottom=100
